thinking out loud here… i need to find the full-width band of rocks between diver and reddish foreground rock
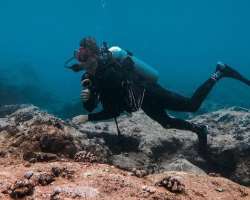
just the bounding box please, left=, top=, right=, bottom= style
left=0, top=105, right=250, bottom=185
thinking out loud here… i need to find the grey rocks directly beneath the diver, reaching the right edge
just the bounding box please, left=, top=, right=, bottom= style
left=76, top=107, right=250, bottom=185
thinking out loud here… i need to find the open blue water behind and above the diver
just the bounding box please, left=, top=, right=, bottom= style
left=0, top=0, right=250, bottom=117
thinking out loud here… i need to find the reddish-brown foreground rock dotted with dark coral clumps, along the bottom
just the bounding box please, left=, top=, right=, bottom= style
left=0, top=160, right=250, bottom=200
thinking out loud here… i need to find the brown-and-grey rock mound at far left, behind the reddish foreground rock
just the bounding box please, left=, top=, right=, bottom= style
left=0, top=105, right=108, bottom=162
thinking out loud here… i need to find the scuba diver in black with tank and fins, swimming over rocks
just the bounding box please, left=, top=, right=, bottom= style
left=69, top=37, right=250, bottom=154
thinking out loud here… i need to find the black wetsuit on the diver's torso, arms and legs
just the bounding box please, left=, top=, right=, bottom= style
left=82, top=57, right=216, bottom=133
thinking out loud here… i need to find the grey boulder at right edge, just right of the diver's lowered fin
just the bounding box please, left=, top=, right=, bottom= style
left=194, top=107, right=250, bottom=185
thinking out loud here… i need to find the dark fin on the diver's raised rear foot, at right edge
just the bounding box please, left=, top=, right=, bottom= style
left=216, top=62, right=250, bottom=86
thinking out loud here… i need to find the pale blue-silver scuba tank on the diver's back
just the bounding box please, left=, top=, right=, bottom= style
left=109, top=46, right=159, bottom=82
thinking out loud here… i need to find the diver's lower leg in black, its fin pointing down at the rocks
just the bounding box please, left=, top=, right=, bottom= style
left=142, top=103, right=208, bottom=153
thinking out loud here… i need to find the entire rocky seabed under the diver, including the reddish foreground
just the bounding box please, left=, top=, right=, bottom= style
left=0, top=105, right=250, bottom=199
